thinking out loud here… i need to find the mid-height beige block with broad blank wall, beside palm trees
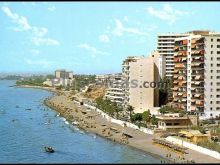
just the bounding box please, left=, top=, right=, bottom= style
left=122, top=52, right=160, bottom=113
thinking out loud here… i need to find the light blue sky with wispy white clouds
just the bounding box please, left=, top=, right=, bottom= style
left=0, top=1, right=220, bottom=74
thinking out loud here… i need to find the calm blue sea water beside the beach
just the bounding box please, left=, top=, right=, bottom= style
left=0, top=81, right=160, bottom=163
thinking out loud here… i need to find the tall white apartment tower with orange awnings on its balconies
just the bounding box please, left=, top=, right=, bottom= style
left=173, top=31, right=220, bottom=118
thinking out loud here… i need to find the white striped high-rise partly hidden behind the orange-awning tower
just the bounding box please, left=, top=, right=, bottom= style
left=157, top=33, right=185, bottom=78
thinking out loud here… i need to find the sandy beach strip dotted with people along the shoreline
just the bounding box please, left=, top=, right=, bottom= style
left=42, top=92, right=219, bottom=163
